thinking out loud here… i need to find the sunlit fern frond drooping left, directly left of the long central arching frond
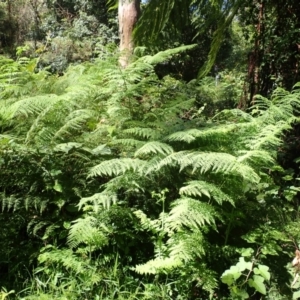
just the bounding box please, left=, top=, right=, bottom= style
left=88, top=158, right=145, bottom=177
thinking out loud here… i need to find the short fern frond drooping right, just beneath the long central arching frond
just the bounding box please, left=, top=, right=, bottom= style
left=179, top=180, right=234, bottom=205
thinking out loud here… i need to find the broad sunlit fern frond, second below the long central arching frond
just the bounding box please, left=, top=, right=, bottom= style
left=165, top=197, right=218, bottom=231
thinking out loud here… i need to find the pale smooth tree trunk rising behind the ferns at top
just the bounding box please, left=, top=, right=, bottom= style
left=118, top=0, right=140, bottom=68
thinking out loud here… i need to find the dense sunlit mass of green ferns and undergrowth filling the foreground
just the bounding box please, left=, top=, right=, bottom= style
left=1, top=46, right=300, bottom=299
